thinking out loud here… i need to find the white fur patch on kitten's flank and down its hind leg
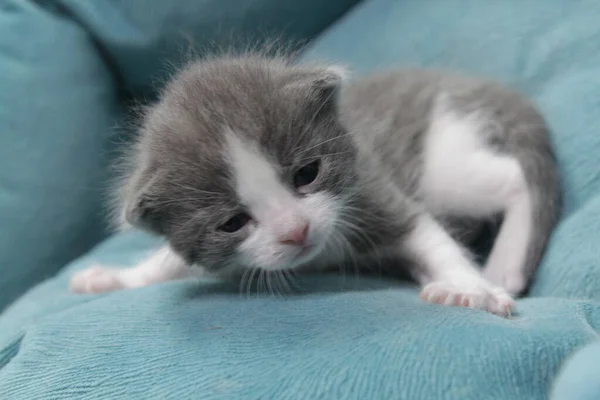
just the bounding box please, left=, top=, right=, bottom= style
left=421, top=102, right=532, bottom=293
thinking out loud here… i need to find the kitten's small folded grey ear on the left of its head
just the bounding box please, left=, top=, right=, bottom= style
left=121, top=173, right=166, bottom=235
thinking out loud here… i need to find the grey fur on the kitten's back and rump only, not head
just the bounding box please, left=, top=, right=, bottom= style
left=340, top=70, right=561, bottom=284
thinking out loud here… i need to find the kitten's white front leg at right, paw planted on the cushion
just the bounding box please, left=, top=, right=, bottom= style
left=403, top=214, right=514, bottom=316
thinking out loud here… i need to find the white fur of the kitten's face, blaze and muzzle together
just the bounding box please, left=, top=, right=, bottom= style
left=226, top=132, right=336, bottom=270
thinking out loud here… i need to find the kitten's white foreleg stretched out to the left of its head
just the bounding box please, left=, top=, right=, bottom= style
left=69, top=246, right=198, bottom=293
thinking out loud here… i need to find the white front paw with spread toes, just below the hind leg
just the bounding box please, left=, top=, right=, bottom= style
left=421, top=281, right=515, bottom=317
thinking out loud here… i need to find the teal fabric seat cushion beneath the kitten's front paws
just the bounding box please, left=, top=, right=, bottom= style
left=0, top=233, right=600, bottom=400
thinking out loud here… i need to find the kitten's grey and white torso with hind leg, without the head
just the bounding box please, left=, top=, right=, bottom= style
left=340, top=70, right=560, bottom=294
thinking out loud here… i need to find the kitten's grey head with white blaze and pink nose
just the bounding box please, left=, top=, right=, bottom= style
left=122, top=57, right=355, bottom=272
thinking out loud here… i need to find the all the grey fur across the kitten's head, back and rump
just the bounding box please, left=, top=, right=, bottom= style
left=119, top=55, right=560, bottom=288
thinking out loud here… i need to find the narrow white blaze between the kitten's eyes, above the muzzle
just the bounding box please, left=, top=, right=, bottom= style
left=225, top=130, right=295, bottom=219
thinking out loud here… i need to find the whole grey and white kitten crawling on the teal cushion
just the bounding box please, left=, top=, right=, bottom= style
left=71, top=54, right=560, bottom=315
